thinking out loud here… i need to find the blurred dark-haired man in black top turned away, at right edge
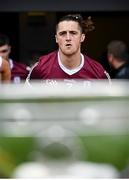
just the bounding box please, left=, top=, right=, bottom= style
left=107, top=40, right=129, bottom=79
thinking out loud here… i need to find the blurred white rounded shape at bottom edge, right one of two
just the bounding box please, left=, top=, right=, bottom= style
left=68, top=162, right=119, bottom=178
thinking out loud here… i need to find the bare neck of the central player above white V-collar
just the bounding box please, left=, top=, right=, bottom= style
left=59, top=51, right=82, bottom=69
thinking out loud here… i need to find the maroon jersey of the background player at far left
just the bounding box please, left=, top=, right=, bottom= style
left=9, top=59, right=30, bottom=83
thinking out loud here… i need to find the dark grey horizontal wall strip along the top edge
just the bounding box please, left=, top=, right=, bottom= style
left=0, top=0, right=129, bottom=12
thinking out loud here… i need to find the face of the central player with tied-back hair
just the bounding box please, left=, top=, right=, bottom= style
left=55, top=21, right=85, bottom=55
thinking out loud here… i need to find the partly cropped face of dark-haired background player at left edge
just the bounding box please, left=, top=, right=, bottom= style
left=0, top=45, right=11, bottom=60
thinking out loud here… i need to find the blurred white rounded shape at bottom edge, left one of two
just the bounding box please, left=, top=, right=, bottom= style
left=12, top=162, right=49, bottom=178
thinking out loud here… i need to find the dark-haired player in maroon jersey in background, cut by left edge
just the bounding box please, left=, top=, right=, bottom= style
left=0, top=34, right=30, bottom=83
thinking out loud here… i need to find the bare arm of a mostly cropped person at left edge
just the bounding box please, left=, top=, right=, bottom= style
left=0, top=56, right=11, bottom=83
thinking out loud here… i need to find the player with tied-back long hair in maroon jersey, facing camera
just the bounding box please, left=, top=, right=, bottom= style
left=27, top=14, right=110, bottom=82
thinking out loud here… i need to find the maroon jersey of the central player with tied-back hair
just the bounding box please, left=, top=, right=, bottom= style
left=28, top=51, right=107, bottom=80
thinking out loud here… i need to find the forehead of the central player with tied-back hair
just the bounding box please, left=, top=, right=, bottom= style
left=57, top=21, right=80, bottom=32
